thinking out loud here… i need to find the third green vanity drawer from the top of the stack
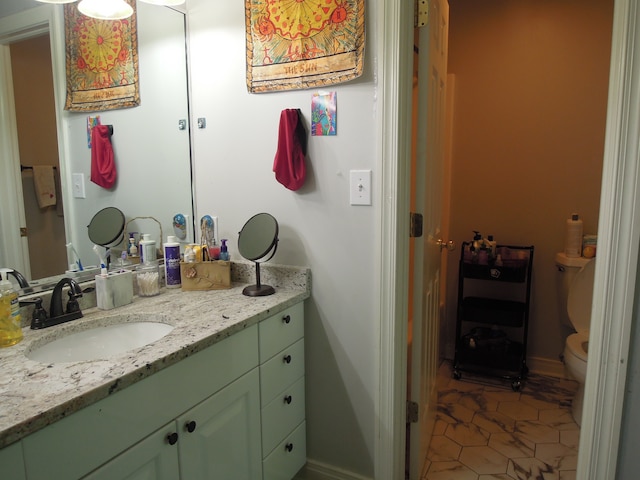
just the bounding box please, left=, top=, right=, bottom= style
left=262, top=377, right=305, bottom=456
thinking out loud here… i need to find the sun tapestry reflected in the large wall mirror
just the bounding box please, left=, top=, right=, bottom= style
left=64, top=0, right=140, bottom=112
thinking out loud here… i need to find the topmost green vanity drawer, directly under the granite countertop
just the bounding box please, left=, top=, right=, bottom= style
left=259, top=302, right=304, bottom=363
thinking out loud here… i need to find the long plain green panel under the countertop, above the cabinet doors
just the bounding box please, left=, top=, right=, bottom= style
left=22, top=325, right=260, bottom=480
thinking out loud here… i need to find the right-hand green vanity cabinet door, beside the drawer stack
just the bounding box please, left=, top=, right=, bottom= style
left=177, top=368, right=262, bottom=480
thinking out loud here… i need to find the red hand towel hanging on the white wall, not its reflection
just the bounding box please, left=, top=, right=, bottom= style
left=273, top=108, right=307, bottom=190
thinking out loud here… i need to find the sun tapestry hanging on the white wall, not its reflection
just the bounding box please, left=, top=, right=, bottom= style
left=245, top=0, right=364, bottom=93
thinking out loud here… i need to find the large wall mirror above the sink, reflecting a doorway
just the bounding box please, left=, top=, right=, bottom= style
left=0, top=1, right=194, bottom=290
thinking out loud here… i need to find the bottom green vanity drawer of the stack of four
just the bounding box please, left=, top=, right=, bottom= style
left=262, top=422, right=307, bottom=480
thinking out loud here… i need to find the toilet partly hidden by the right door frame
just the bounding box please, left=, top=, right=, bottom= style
left=556, top=253, right=596, bottom=425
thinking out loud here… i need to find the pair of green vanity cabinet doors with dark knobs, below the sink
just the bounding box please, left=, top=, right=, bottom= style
left=84, top=369, right=262, bottom=480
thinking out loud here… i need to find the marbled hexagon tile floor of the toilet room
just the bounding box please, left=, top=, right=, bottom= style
left=422, top=363, right=580, bottom=480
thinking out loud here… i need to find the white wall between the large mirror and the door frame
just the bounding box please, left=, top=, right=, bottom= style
left=188, top=0, right=381, bottom=476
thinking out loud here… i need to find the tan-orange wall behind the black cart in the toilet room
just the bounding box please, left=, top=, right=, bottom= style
left=443, top=0, right=613, bottom=366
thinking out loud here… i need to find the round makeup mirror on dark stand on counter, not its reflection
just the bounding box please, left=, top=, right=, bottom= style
left=238, top=213, right=278, bottom=297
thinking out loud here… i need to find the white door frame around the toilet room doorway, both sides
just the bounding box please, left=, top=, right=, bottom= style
left=375, top=0, right=640, bottom=480
